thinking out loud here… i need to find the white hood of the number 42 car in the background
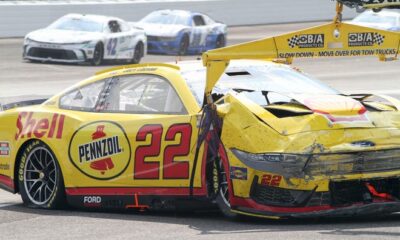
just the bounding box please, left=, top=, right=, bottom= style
left=26, top=29, right=103, bottom=44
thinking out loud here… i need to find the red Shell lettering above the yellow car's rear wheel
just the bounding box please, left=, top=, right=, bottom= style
left=15, top=112, right=65, bottom=140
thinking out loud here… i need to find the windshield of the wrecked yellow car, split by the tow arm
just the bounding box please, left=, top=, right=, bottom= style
left=183, top=64, right=340, bottom=105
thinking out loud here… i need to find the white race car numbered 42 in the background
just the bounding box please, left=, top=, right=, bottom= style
left=23, top=14, right=147, bottom=65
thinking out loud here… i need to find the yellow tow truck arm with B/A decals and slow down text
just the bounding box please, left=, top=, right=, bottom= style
left=202, top=2, right=400, bottom=103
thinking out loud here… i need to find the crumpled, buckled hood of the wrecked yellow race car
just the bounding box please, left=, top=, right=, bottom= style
left=219, top=94, right=400, bottom=135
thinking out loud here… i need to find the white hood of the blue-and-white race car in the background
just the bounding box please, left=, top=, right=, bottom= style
left=132, top=22, right=186, bottom=37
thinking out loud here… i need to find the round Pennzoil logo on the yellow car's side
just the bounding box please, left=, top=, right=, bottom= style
left=69, top=121, right=131, bottom=180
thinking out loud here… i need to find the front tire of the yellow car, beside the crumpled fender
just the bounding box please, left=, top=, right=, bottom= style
left=213, top=159, right=239, bottom=219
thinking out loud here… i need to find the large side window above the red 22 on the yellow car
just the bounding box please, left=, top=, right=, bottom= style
left=97, top=74, right=187, bottom=114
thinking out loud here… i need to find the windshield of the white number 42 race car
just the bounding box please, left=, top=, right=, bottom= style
left=48, top=17, right=103, bottom=32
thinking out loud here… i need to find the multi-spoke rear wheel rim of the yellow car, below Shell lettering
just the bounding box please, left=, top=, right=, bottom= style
left=24, top=147, right=57, bottom=205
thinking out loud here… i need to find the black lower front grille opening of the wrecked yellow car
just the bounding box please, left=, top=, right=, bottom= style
left=250, top=177, right=400, bottom=207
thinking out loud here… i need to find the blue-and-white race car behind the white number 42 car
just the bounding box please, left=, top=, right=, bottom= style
left=133, top=10, right=227, bottom=55
